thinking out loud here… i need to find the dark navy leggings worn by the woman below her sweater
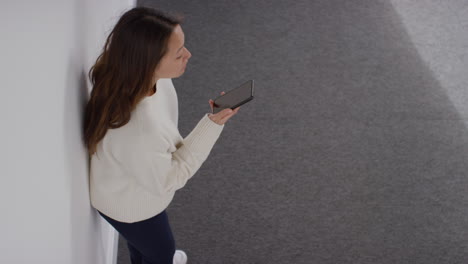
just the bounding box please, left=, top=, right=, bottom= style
left=98, top=210, right=175, bottom=264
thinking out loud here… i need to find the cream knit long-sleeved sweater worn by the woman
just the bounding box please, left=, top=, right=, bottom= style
left=89, top=79, right=224, bottom=223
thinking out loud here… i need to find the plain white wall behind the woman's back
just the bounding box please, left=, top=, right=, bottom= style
left=0, top=0, right=135, bottom=264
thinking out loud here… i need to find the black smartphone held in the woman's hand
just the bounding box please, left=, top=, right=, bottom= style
left=213, top=80, right=254, bottom=114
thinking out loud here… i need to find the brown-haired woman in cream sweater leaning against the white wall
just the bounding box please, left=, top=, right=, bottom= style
left=84, top=7, right=239, bottom=264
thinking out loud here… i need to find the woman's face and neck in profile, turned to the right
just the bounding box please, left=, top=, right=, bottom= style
left=155, top=25, right=192, bottom=80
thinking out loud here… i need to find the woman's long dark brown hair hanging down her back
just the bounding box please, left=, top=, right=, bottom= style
left=84, top=7, right=183, bottom=156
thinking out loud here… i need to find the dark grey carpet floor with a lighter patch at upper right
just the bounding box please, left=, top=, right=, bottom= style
left=118, top=0, right=468, bottom=264
